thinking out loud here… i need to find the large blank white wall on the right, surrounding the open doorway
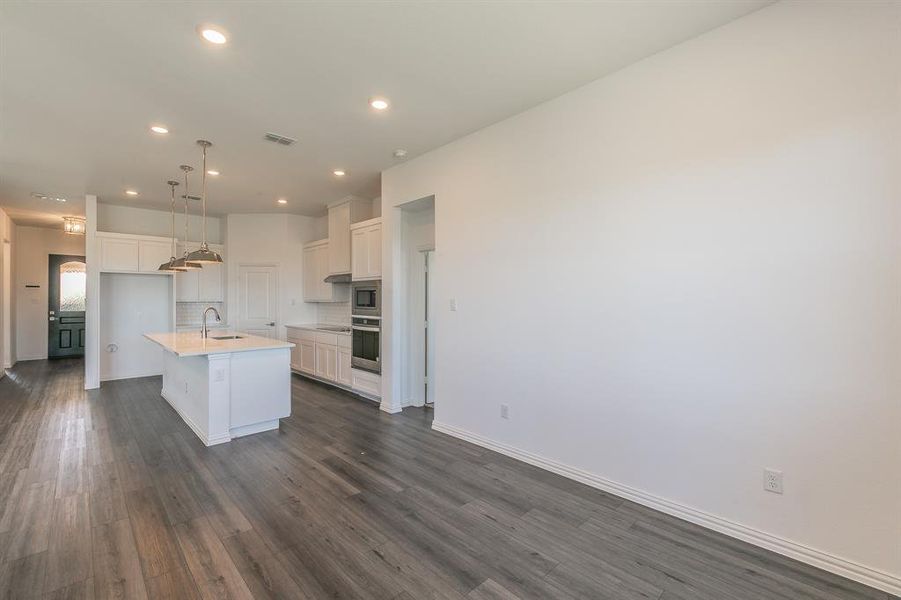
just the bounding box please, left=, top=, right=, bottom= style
left=382, top=2, right=901, bottom=592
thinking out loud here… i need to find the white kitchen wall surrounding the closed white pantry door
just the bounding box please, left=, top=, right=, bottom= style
left=226, top=214, right=323, bottom=339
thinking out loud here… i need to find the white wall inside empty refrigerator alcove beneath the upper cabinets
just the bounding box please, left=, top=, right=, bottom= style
left=100, top=273, right=173, bottom=381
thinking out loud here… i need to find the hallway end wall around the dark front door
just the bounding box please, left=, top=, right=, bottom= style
left=16, top=225, right=85, bottom=360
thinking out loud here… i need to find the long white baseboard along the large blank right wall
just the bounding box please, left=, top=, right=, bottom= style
left=432, top=421, right=901, bottom=595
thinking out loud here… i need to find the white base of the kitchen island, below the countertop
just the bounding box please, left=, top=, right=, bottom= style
left=161, top=348, right=291, bottom=446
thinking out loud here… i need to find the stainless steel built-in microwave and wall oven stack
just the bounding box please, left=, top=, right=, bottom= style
left=350, top=281, right=382, bottom=373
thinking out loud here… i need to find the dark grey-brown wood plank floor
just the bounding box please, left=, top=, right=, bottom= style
left=0, top=360, right=888, bottom=600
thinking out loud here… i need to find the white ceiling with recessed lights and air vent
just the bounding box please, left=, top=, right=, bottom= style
left=0, top=0, right=769, bottom=224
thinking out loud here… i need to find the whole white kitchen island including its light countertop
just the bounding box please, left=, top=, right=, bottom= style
left=144, top=330, right=294, bottom=446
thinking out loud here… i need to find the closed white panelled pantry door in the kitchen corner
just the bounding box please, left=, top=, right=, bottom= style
left=238, top=265, right=278, bottom=338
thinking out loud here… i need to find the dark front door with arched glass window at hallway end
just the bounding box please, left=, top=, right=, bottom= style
left=47, top=254, right=87, bottom=358
